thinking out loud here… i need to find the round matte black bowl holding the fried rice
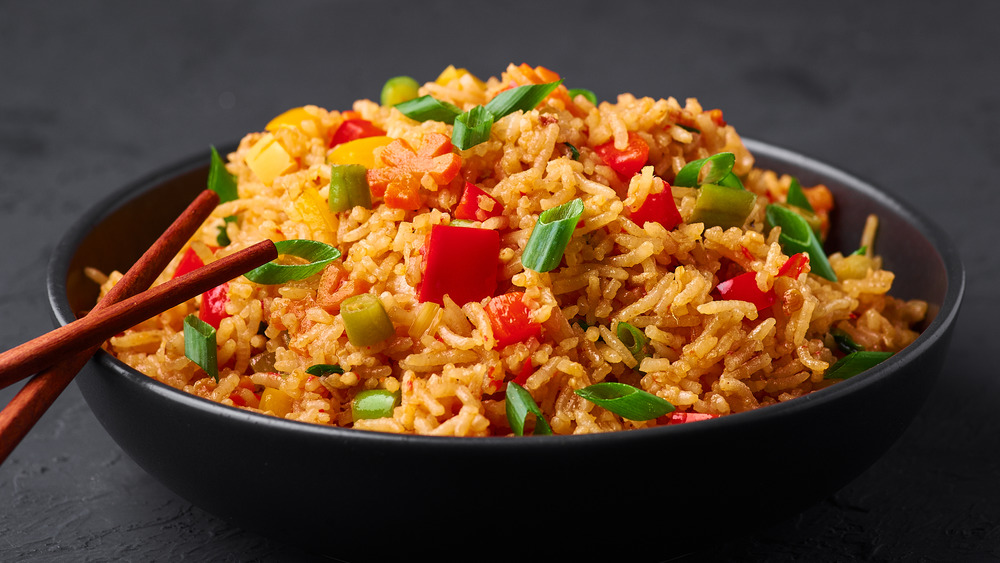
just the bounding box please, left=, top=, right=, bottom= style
left=48, top=141, right=965, bottom=560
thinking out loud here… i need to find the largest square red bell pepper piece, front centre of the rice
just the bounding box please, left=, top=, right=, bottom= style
left=417, top=225, right=500, bottom=305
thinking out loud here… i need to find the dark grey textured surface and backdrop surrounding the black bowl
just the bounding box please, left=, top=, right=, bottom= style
left=0, top=0, right=1000, bottom=561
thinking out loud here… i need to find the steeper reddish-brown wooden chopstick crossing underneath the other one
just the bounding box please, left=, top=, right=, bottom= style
left=0, top=190, right=270, bottom=463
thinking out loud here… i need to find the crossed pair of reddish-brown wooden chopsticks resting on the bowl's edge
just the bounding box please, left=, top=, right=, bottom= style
left=0, top=190, right=278, bottom=464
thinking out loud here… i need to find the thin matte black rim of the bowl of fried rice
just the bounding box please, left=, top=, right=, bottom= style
left=46, top=137, right=966, bottom=452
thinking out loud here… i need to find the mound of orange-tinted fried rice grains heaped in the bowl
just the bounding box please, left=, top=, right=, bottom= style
left=102, top=65, right=926, bottom=436
